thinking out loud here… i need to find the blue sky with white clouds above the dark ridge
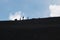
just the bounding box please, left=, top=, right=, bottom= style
left=0, top=0, right=60, bottom=20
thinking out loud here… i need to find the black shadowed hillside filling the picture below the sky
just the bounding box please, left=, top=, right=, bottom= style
left=0, top=17, right=60, bottom=40
